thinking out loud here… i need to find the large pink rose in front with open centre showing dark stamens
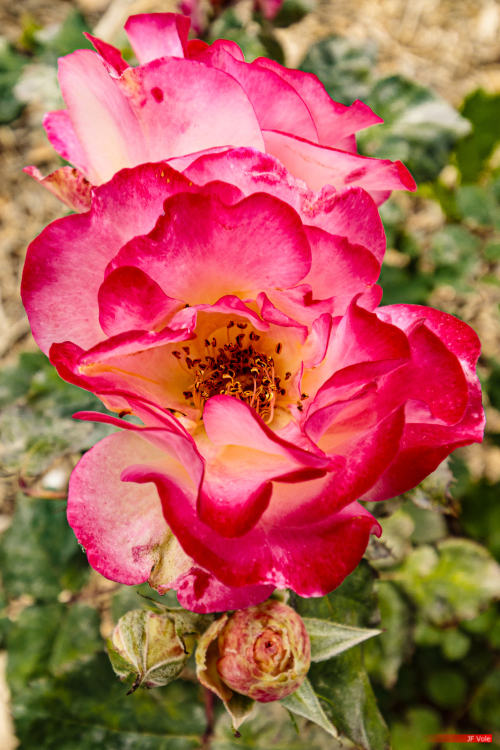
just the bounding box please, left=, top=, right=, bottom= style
left=22, top=151, right=483, bottom=611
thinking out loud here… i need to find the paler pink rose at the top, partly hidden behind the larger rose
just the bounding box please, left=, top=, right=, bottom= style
left=27, top=13, right=415, bottom=210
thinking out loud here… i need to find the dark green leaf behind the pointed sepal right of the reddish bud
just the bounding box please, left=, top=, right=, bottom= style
left=296, top=563, right=389, bottom=750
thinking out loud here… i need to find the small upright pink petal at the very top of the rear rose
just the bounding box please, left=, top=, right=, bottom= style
left=125, top=13, right=190, bottom=65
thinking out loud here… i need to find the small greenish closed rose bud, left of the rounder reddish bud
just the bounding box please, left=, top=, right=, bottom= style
left=108, top=609, right=188, bottom=693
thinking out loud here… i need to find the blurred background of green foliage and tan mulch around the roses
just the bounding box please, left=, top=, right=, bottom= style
left=0, top=0, right=500, bottom=750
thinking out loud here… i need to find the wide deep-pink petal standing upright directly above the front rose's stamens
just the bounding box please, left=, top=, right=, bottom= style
left=110, top=193, right=311, bottom=305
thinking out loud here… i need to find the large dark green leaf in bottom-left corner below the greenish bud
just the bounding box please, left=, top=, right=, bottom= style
left=12, top=653, right=205, bottom=750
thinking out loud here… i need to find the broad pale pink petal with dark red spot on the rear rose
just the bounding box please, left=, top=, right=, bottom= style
left=119, top=58, right=264, bottom=164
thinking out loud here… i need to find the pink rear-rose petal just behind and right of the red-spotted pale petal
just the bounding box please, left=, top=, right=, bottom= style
left=186, top=41, right=318, bottom=142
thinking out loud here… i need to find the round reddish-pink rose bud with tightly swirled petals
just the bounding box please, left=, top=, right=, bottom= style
left=197, top=599, right=311, bottom=703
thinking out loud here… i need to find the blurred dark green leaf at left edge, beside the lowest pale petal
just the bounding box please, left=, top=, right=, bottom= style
left=0, top=495, right=88, bottom=600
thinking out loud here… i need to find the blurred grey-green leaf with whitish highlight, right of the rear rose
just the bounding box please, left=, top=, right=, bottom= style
left=359, top=75, right=470, bottom=182
